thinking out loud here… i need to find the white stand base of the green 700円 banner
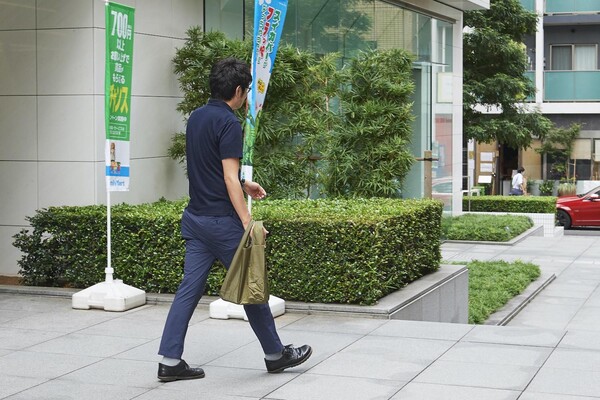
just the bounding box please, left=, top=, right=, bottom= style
left=72, top=279, right=146, bottom=311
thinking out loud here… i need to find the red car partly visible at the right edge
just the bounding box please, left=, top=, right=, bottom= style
left=556, top=186, right=600, bottom=229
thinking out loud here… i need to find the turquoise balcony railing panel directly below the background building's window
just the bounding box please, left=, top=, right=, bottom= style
left=544, top=71, right=600, bottom=101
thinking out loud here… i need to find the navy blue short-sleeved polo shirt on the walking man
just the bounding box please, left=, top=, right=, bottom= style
left=186, top=99, right=242, bottom=215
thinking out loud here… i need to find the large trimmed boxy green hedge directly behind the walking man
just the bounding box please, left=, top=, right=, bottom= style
left=14, top=199, right=442, bottom=304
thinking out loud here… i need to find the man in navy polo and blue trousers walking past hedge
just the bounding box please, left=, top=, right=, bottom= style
left=158, top=58, right=312, bottom=382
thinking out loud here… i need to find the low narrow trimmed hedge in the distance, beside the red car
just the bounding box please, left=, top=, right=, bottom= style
left=463, top=196, right=556, bottom=214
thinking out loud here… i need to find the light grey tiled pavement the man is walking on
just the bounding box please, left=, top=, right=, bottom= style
left=0, top=236, right=600, bottom=400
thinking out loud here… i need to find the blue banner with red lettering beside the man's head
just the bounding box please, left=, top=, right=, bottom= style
left=242, top=0, right=287, bottom=188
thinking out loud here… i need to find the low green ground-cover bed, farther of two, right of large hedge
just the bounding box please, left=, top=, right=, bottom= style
left=442, top=214, right=533, bottom=242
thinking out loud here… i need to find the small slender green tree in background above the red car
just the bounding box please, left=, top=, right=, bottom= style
left=535, top=124, right=581, bottom=180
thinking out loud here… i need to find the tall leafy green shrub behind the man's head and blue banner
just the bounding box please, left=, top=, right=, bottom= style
left=169, top=27, right=337, bottom=198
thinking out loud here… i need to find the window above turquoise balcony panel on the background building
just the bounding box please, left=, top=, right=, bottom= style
left=550, top=44, right=598, bottom=71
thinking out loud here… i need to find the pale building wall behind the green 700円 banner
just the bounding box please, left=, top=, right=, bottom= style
left=0, top=0, right=203, bottom=276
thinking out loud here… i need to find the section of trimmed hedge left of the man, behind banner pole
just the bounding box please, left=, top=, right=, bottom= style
left=14, top=202, right=190, bottom=293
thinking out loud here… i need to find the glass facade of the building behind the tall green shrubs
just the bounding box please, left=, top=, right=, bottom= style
left=204, top=0, right=453, bottom=210
